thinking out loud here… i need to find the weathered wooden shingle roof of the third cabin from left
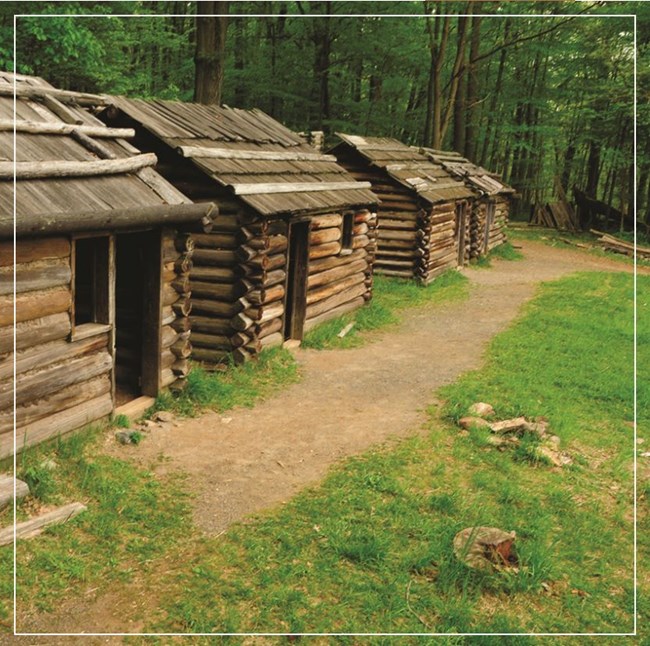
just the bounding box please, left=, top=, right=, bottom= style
left=336, top=133, right=475, bottom=204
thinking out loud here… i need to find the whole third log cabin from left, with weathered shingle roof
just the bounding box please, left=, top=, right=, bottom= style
left=330, top=133, right=475, bottom=285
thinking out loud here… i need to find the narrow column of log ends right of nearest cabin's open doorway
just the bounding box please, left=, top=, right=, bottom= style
left=160, top=230, right=194, bottom=389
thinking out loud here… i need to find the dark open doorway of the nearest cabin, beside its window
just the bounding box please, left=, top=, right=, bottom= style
left=115, top=231, right=161, bottom=406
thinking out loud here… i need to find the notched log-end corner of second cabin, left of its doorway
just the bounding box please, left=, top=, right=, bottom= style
left=230, top=218, right=288, bottom=363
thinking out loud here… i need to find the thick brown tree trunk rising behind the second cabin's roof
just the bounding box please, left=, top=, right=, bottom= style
left=194, top=0, right=229, bottom=105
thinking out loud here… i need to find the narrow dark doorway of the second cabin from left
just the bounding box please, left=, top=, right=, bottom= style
left=284, top=222, right=309, bottom=340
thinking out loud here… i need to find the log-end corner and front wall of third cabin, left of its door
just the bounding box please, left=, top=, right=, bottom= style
left=416, top=202, right=456, bottom=284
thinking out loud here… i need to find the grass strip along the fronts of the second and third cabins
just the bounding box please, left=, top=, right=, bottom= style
left=302, top=270, right=469, bottom=350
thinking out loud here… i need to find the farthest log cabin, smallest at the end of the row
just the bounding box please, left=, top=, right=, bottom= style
left=418, top=148, right=516, bottom=259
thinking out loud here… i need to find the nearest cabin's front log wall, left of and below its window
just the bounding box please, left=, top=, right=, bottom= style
left=0, top=237, right=113, bottom=457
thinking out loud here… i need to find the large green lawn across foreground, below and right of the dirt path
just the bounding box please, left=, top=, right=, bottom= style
left=5, top=273, right=650, bottom=644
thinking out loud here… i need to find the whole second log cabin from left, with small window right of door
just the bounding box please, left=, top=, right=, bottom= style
left=100, top=97, right=377, bottom=363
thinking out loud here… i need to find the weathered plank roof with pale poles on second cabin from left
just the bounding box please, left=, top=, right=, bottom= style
left=113, top=97, right=378, bottom=216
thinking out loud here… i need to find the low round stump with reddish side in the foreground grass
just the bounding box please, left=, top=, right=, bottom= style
left=454, top=527, right=517, bottom=570
